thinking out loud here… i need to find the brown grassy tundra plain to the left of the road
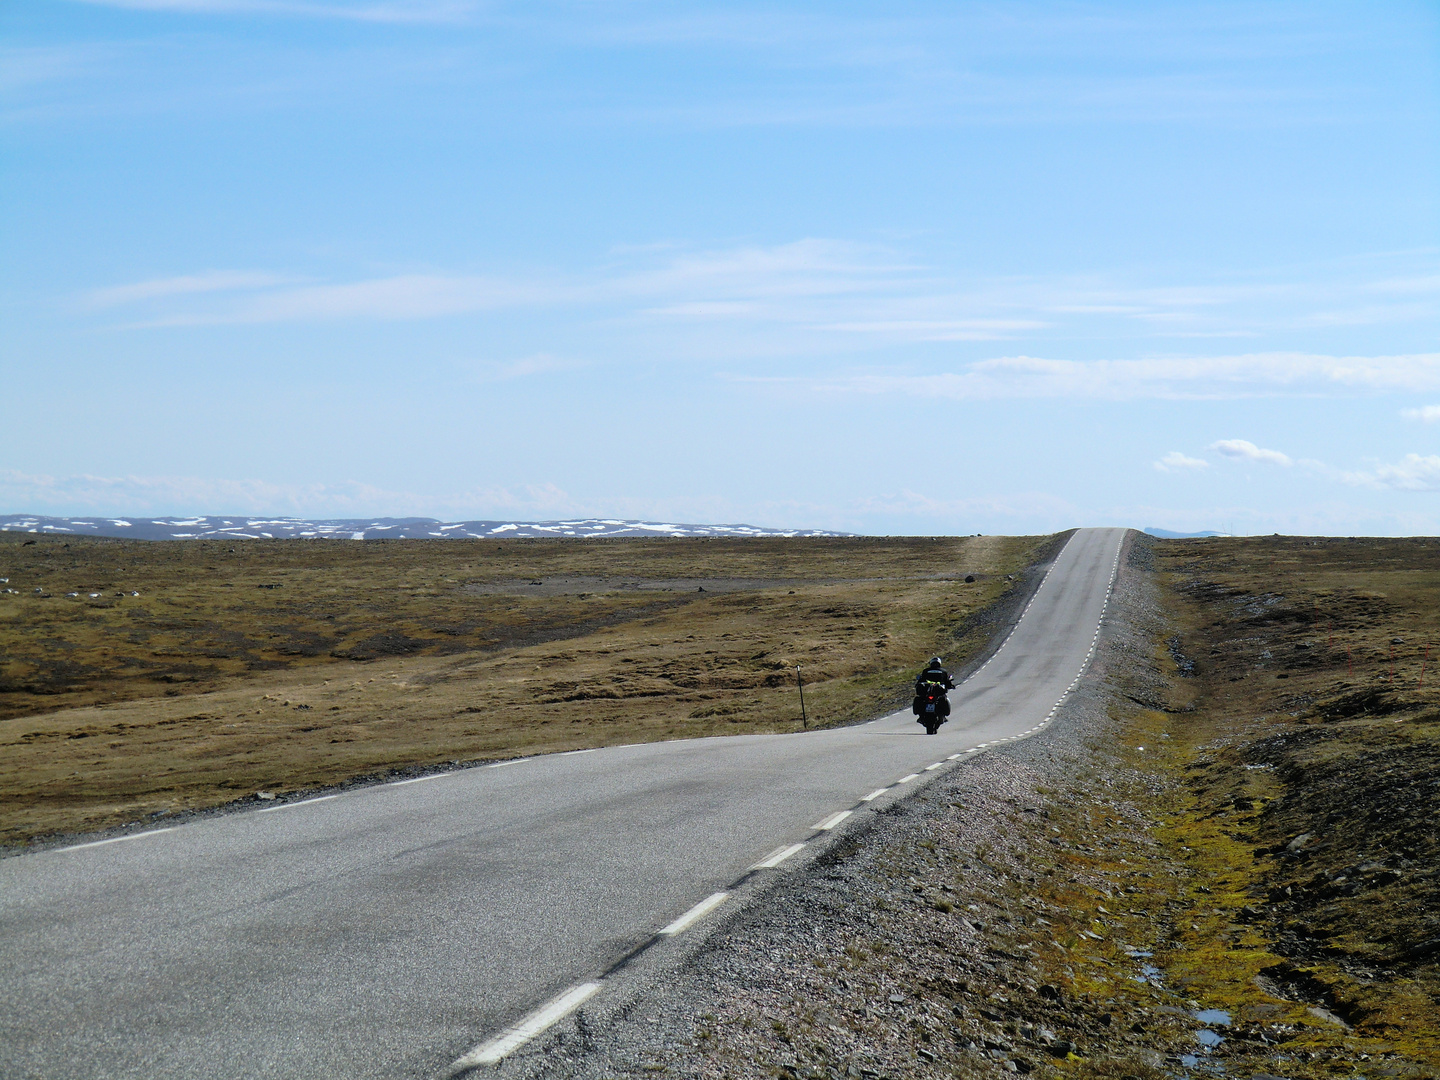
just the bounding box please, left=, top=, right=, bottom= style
left=0, top=534, right=1045, bottom=844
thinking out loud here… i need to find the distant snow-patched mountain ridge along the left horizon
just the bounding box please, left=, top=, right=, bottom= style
left=0, top=514, right=852, bottom=540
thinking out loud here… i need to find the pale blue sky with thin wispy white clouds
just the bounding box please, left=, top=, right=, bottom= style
left=0, top=0, right=1440, bottom=536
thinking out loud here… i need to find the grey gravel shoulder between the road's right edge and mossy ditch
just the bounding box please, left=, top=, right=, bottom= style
left=478, top=534, right=1164, bottom=1080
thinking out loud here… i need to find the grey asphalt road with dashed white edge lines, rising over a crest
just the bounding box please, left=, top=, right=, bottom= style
left=0, top=528, right=1125, bottom=1080
